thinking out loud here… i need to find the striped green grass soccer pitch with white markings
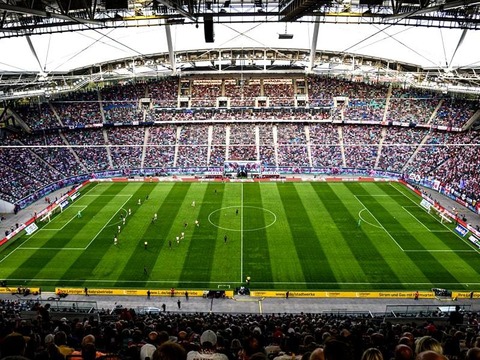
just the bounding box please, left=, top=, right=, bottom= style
left=0, top=182, right=480, bottom=290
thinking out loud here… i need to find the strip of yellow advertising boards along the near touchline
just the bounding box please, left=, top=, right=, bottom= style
left=55, top=288, right=480, bottom=301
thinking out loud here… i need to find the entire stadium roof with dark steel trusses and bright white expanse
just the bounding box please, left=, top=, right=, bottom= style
left=0, top=0, right=480, bottom=97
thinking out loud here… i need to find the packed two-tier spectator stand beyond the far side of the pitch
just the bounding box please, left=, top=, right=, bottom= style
left=0, top=76, right=479, bottom=217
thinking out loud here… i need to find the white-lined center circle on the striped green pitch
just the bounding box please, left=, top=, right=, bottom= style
left=208, top=205, right=277, bottom=231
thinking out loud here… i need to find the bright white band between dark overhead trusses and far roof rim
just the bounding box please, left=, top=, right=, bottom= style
left=0, top=23, right=480, bottom=73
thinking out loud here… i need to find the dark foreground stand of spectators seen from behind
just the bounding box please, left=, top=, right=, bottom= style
left=0, top=296, right=480, bottom=360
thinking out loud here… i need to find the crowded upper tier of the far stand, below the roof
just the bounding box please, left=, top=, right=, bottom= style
left=16, top=76, right=478, bottom=130
